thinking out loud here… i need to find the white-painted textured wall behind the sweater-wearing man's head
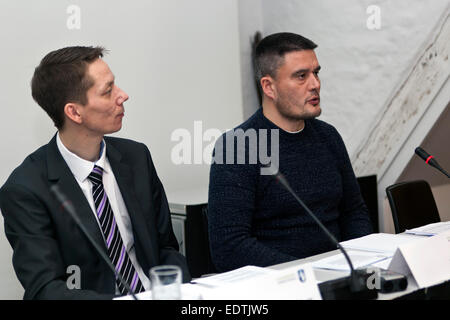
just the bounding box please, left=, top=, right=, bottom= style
left=240, top=0, right=448, bottom=158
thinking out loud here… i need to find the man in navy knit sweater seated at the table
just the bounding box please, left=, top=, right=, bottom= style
left=208, top=33, right=372, bottom=271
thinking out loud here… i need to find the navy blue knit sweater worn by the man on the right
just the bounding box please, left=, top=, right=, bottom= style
left=208, top=109, right=372, bottom=271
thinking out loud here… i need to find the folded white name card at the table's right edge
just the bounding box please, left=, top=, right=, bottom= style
left=389, top=230, right=450, bottom=289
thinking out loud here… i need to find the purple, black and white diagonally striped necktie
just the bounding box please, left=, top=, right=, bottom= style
left=88, top=166, right=145, bottom=294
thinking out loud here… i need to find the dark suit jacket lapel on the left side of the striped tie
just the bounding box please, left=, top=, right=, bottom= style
left=47, top=135, right=106, bottom=253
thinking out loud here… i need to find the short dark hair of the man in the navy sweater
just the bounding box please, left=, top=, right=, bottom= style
left=253, top=32, right=317, bottom=87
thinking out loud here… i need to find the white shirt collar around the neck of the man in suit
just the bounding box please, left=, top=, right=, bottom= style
left=56, top=132, right=107, bottom=183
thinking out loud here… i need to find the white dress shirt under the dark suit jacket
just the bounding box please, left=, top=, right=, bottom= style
left=56, top=132, right=150, bottom=293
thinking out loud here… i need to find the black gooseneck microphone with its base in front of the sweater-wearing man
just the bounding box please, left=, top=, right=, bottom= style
left=272, top=171, right=378, bottom=300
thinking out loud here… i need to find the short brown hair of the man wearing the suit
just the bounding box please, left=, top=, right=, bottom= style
left=31, top=46, right=105, bottom=129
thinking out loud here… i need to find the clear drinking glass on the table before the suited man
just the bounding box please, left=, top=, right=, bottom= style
left=150, top=265, right=181, bottom=300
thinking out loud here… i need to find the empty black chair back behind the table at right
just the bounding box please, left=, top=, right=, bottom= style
left=386, top=180, right=441, bottom=233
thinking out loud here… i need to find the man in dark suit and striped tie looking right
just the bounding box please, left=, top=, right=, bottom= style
left=0, top=47, right=190, bottom=299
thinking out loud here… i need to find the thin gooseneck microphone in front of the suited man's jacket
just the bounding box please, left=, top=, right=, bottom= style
left=50, top=184, right=138, bottom=300
